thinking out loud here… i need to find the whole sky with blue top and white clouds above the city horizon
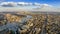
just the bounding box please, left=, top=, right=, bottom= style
left=0, top=0, right=60, bottom=11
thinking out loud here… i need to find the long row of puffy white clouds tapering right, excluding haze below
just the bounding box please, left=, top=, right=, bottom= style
left=0, top=2, right=50, bottom=7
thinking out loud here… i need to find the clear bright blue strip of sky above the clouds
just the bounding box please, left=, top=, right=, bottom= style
left=0, top=0, right=60, bottom=7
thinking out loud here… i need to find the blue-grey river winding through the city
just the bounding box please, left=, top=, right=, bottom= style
left=0, top=15, right=32, bottom=34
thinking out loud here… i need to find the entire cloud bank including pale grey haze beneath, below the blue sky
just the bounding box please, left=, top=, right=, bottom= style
left=0, top=2, right=60, bottom=11
